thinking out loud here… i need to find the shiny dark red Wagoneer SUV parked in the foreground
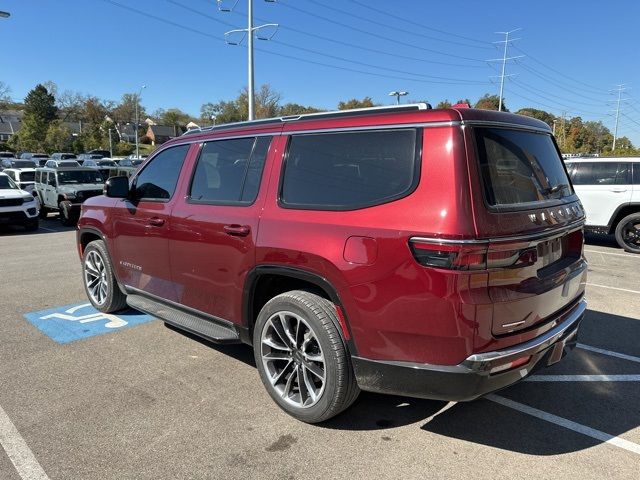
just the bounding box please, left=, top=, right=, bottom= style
left=77, top=104, right=587, bottom=422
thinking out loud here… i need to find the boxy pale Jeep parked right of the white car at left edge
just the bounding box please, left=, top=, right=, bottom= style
left=36, top=167, right=104, bottom=225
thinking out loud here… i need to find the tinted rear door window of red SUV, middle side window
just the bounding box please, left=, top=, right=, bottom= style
left=190, top=137, right=271, bottom=203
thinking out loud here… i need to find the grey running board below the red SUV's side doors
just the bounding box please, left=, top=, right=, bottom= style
left=127, top=294, right=240, bottom=343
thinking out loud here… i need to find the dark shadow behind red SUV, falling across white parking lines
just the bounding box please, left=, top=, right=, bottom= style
left=421, top=310, right=640, bottom=455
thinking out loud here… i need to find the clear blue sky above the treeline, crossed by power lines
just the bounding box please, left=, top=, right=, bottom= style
left=0, top=0, right=640, bottom=145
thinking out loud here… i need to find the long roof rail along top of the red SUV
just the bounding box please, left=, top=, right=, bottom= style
left=182, top=103, right=432, bottom=137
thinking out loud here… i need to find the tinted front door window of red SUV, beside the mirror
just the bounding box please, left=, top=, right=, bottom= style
left=135, top=145, right=189, bottom=200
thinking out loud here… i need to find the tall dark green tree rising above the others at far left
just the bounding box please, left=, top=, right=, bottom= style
left=11, top=84, right=58, bottom=150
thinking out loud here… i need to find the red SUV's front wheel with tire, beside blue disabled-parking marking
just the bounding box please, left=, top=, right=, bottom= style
left=82, top=240, right=127, bottom=313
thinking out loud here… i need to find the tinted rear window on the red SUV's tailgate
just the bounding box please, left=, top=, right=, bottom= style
left=474, top=127, right=573, bottom=207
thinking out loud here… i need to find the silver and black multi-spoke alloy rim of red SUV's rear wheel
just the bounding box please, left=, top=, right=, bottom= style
left=260, top=311, right=326, bottom=408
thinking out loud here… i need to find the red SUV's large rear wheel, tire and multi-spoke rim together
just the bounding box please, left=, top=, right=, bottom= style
left=253, top=290, right=360, bottom=423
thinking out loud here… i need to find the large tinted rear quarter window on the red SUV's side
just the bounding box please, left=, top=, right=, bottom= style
left=280, top=129, right=420, bottom=210
